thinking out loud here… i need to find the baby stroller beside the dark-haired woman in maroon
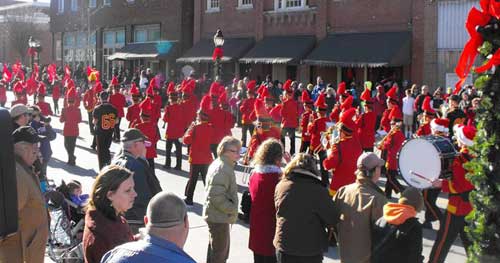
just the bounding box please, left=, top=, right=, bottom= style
left=44, top=182, right=84, bottom=263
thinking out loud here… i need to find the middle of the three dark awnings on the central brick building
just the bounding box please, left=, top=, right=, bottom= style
left=240, top=36, right=315, bottom=64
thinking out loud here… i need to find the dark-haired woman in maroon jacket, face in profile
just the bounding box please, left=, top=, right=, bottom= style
left=83, top=165, right=137, bottom=263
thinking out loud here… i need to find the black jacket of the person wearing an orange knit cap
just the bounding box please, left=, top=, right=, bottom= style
left=372, top=217, right=424, bottom=263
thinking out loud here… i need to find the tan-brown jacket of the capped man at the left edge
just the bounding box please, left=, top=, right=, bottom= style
left=0, top=158, right=49, bottom=263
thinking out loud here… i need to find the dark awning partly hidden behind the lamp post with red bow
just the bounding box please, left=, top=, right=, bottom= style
left=176, top=38, right=255, bottom=63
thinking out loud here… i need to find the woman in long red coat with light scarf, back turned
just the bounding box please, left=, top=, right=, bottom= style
left=248, top=139, right=283, bottom=263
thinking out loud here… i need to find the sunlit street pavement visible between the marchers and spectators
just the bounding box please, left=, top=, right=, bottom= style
left=3, top=92, right=466, bottom=263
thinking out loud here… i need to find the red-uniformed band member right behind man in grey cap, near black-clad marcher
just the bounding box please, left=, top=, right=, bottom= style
left=134, top=99, right=160, bottom=173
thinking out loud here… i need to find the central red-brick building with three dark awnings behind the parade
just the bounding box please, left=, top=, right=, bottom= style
left=177, top=0, right=437, bottom=85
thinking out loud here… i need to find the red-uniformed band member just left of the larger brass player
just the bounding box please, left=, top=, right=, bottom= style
left=307, top=93, right=330, bottom=187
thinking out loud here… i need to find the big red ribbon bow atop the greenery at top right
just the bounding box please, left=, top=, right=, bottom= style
left=453, top=0, right=500, bottom=94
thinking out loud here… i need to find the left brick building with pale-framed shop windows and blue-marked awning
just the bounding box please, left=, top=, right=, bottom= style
left=51, top=0, right=193, bottom=79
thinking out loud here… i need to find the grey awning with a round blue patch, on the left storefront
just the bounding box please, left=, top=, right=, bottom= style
left=108, top=41, right=177, bottom=60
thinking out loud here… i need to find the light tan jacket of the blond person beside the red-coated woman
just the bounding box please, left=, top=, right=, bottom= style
left=203, top=157, right=238, bottom=224
